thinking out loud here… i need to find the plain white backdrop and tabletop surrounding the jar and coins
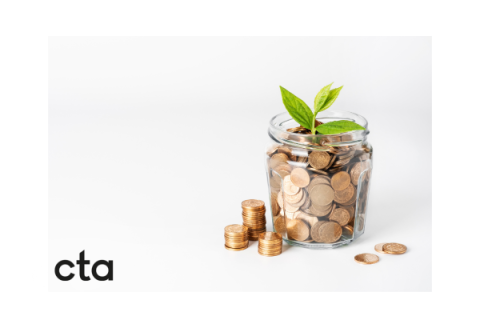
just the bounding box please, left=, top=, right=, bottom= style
left=49, top=37, right=432, bottom=291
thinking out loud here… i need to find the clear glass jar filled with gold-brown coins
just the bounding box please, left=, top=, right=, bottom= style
left=265, top=110, right=372, bottom=249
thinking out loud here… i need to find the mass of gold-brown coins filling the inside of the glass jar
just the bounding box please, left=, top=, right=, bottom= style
left=267, top=140, right=372, bottom=243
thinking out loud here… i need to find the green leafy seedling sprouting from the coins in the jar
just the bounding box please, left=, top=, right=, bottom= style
left=280, top=82, right=365, bottom=134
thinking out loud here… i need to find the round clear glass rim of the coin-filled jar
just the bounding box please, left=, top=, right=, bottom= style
left=268, top=110, right=370, bottom=148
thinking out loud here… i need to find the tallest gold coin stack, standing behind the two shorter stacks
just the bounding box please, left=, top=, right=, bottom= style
left=242, top=199, right=267, bottom=240
